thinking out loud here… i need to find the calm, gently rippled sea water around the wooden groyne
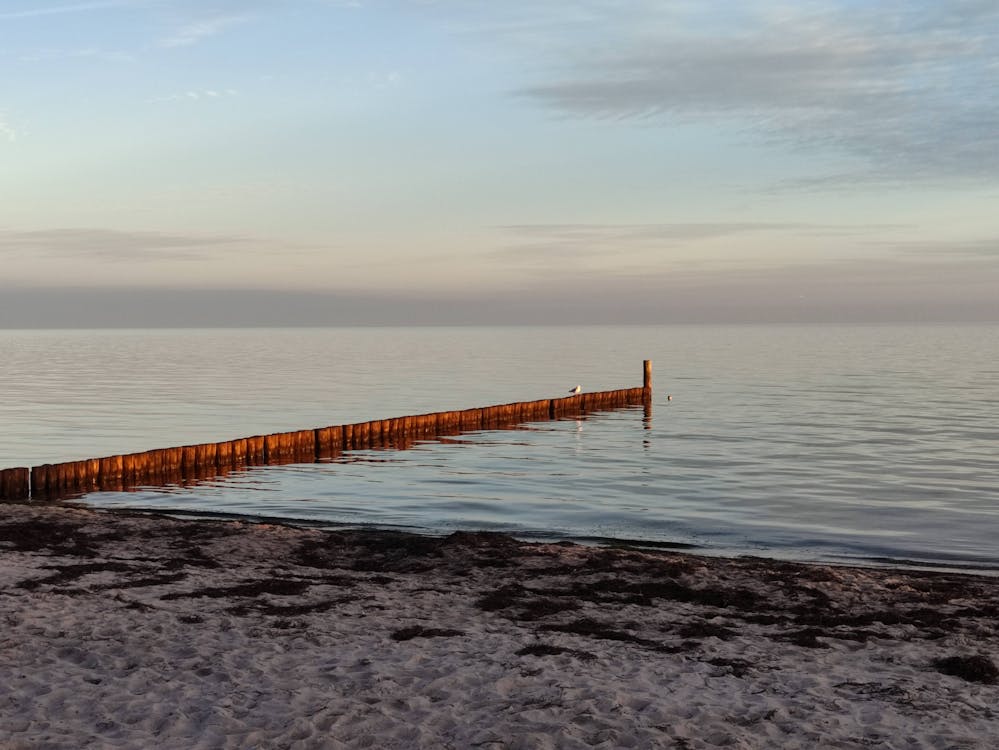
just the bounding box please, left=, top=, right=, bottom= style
left=0, top=326, right=999, bottom=571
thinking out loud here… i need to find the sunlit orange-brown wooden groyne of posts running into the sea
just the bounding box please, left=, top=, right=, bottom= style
left=0, top=360, right=652, bottom=500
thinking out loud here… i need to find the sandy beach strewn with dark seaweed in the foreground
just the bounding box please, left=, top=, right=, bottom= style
left=0, top=505, right=999, bottom=750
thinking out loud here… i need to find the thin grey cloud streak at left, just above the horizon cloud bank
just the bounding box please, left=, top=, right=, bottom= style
left=0, top=229, right=250, bottom=263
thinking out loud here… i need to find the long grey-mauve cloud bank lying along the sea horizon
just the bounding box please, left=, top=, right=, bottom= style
left=0, top=262, right=999, bottom=328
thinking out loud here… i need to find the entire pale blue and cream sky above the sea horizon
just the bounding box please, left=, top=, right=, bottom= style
left=0, top=0, right=999, bottom=328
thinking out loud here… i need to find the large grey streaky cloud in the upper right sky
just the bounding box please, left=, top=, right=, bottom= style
left=517, top=0, right=999, bottom=187
